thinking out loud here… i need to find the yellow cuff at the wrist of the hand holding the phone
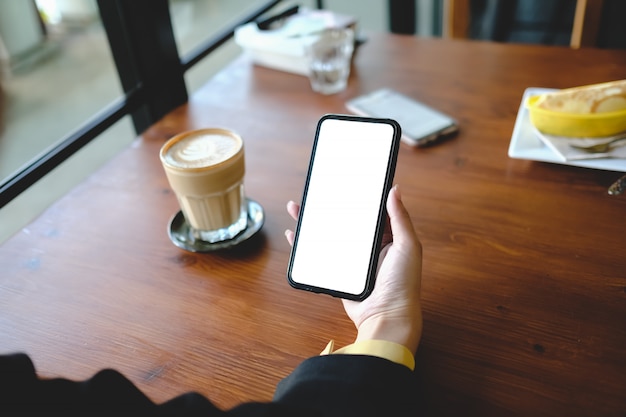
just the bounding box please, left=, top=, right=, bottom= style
left=320, top=340, right=415, bottom=370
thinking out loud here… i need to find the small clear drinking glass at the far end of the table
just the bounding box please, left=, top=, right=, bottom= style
left=307, top=28, right=354, bottom=94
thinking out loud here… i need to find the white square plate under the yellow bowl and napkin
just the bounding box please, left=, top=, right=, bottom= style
left=509, top=87, right=626, bottom=172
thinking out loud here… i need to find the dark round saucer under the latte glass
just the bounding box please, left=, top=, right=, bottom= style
left=167, top=198, right=265, bottom=252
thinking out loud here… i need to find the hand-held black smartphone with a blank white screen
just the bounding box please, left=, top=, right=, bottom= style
left=287, top=114, right=402, bottom=300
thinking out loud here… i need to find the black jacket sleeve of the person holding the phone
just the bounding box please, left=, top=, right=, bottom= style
left=0, top=354, right=418, bottom=417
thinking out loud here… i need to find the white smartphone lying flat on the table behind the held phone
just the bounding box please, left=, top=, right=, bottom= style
left=346, top=88, right=458, bottom=146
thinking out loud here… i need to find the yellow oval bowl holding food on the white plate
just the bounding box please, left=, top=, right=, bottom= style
left=526, top=96, right=626, bottom=138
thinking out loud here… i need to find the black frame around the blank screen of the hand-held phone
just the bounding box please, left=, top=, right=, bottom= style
left=287, top=114, right=402, bottom=301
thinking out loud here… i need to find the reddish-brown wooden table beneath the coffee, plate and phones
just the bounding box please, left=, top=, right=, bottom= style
left=0, top=34, right=626, bottom=416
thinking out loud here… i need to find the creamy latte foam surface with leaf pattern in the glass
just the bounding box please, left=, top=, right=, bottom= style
left=165, top=134, right=241, bottom=168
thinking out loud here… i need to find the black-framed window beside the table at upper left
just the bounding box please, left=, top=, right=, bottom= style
left=0, top=0, right=288, bottom=240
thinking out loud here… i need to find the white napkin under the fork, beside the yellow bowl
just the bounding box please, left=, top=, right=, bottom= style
left=533, top=126, right=626, bottom=162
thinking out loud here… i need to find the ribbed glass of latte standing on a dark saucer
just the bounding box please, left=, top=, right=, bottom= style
left=160, top=128, right=248, bottom=243
